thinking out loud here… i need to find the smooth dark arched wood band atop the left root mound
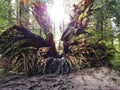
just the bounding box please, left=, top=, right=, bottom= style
left=2, top=26, right=48, bottom=48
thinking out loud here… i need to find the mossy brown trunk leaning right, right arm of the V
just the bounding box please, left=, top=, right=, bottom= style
left=61, top=0, right=95, bottom=53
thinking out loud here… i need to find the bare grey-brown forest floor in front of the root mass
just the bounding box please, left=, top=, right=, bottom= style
left=0, top=67, right=120, bottom=90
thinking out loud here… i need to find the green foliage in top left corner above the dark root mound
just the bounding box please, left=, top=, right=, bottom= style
left=0, top=0, right=15, bottom=34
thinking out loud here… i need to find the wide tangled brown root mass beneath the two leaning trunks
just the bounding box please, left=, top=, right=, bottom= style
left=0, top=26, right=114, bottom=75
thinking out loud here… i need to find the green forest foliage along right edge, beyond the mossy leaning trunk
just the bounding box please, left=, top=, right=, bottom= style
left=88, top=0, right=120, bottom=70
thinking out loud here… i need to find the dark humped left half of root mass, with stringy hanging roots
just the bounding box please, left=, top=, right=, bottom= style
left=0, top=26, right=57, bottom=74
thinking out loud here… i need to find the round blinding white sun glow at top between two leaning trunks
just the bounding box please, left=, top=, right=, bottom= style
left=48, top=0, right=69, bottom=24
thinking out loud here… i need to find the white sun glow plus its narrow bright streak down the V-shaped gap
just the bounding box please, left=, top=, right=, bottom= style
left=48, top=0, right=70, bottom=50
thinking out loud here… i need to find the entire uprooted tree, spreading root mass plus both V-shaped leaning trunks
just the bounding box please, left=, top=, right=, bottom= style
left=0, top=0, right=114, bottom=75
